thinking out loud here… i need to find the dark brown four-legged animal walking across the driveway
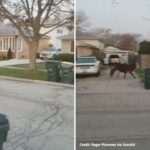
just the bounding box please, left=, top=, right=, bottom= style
left=110, top=64, right=136, bottom=78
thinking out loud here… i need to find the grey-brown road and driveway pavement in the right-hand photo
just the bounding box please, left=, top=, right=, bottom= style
left=76, top=69, right=150, bottom=150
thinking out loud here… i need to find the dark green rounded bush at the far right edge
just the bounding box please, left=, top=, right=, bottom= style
left=139, top=41, right=150, bottom=54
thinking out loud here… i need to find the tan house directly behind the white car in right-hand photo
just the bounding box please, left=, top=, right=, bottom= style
left=76, top=32, right=104, bottom=58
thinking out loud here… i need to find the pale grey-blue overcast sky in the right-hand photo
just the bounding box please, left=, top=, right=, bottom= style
left=76, top=0, right=150, bottom=39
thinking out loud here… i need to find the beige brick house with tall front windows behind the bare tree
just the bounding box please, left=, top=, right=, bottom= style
left=0, top=24, right=50, bottom=58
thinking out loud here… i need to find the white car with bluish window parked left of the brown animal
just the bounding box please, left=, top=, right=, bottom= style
left=76, top=56, right=101, bottom=75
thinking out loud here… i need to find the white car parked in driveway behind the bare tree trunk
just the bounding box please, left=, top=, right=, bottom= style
left=40, top=47, right=61, bottom=59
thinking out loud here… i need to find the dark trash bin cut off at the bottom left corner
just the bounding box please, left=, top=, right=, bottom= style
left=0, top=114, right=9, bottom=150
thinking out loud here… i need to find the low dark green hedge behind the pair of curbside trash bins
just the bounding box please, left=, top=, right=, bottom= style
left=52, top=53, right=74, bottom=63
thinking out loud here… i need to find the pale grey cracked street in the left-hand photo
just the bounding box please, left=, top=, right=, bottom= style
left=0, top=79, right=74, bottom=150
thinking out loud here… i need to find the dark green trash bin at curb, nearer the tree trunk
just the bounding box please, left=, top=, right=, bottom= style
left=46, top=60, right=61, bottom=82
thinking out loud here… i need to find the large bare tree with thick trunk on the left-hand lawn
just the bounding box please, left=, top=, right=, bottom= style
left=0, top=0, right=74, bottom=71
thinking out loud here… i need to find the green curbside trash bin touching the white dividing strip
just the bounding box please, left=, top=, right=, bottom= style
left=60, top=66, right=74, bottom=84
